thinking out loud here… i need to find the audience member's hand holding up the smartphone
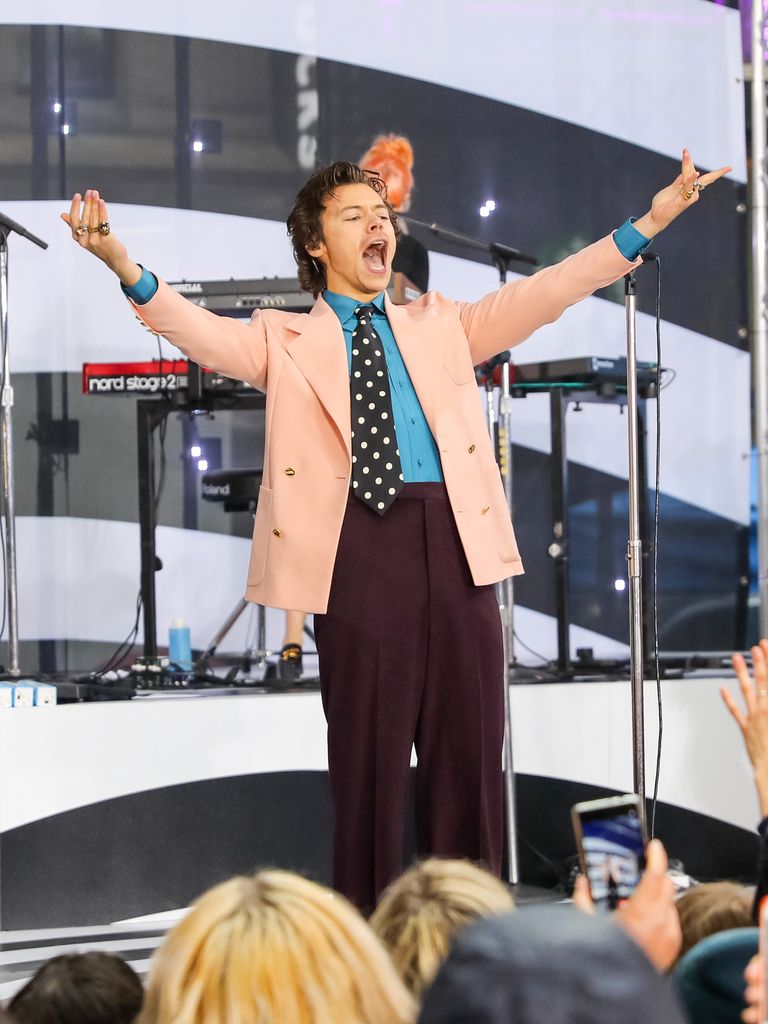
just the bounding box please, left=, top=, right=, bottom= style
left=573, top=839, right=683, bottom=971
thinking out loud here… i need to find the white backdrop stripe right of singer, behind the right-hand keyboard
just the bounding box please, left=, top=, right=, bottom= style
left=429, top=253, right=751, bottom=528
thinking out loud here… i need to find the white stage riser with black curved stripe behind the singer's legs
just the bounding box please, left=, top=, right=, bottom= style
left=0, top=675, right=759, bottom=930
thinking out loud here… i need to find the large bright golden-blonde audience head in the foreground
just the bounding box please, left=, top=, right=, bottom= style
left=138, top=870, right=415, bottom=1024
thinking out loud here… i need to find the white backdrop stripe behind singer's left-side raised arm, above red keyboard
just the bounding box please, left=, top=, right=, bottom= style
left=2, top=196, right=296, bottom=376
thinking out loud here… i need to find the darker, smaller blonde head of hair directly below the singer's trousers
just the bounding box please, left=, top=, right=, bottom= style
left=371, top=857, right=515, bottom=999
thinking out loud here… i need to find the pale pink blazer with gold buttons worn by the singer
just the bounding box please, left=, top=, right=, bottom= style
left=135, top=237, right=635, bottom=612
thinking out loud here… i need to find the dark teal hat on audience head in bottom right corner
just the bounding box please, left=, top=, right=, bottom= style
left=674, top=928, right=758, bottom=1024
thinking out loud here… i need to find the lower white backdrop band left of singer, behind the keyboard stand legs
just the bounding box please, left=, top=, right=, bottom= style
left=16, top=516, right=294, bottom=651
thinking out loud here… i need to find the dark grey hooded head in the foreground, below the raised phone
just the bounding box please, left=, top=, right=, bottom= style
left=419, top=906, right=683, bottom=1024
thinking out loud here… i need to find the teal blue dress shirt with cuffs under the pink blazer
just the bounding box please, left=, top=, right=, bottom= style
left=121, top=217, right=651, bottom=483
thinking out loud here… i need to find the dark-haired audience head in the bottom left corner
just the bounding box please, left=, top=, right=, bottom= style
left=8, top=952, right=143, bottom=1024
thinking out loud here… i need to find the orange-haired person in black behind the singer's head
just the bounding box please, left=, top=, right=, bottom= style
left=358, top=134, right=429, bottom=301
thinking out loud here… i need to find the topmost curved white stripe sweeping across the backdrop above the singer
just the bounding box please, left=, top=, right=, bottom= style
left=4, top=0, right=746, bottom=180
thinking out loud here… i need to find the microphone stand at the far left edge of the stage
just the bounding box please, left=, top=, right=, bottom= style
left=0, top=213, right=48, bottom=678
